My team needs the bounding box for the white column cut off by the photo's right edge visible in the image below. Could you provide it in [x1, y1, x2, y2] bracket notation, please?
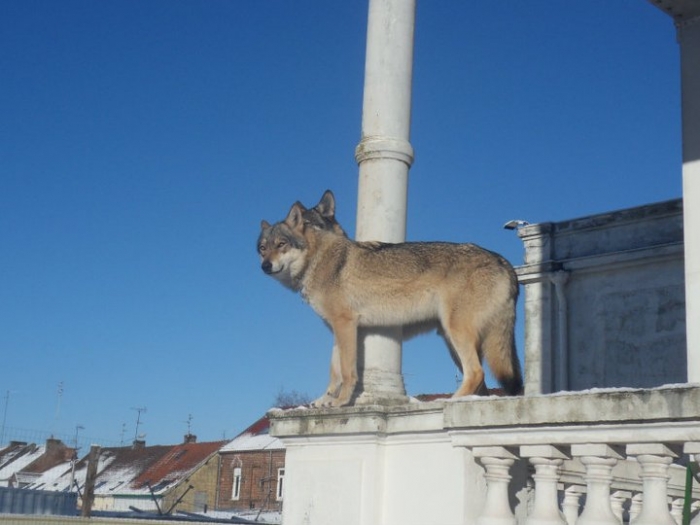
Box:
[677, 12, 700, 383]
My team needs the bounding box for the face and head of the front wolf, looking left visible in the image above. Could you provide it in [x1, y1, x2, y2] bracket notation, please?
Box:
[258, 202, 308, 290]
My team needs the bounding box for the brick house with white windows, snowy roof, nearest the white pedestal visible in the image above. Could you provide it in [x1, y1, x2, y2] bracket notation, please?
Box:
[217, 415, 285, 510]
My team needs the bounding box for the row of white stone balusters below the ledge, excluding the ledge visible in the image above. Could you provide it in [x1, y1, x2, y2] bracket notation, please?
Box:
[464, 442, 700, 525]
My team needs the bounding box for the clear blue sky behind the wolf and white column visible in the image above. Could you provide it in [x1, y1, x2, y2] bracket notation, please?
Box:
[0, 0, 681, 445]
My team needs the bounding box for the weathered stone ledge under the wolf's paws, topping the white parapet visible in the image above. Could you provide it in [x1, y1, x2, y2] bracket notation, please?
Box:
[268, 385, 700, 441]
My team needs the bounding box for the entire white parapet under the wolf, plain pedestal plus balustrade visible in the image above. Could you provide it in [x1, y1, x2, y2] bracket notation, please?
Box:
[270, 385, 700, 525]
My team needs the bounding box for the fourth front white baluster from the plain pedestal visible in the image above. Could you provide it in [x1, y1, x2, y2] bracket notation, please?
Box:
[627, 443, 678, 525]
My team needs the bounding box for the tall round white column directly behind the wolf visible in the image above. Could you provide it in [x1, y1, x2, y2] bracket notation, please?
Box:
[355, 0, 415, 403]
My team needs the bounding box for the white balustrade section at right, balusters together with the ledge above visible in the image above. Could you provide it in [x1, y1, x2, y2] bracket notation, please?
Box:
[448, 384, 700, 525]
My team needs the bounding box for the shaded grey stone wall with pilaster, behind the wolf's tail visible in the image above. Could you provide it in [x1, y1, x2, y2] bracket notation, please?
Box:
[518, 199, 687, 394]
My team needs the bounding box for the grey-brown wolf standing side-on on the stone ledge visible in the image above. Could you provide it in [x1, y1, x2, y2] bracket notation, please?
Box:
[257, 190, 523, 407]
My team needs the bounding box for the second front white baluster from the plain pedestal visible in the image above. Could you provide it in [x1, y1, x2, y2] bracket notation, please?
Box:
[520, 445, 568, 525]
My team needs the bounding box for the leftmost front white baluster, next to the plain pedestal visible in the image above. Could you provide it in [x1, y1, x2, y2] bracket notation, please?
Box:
[472, 447, 518, 525]
